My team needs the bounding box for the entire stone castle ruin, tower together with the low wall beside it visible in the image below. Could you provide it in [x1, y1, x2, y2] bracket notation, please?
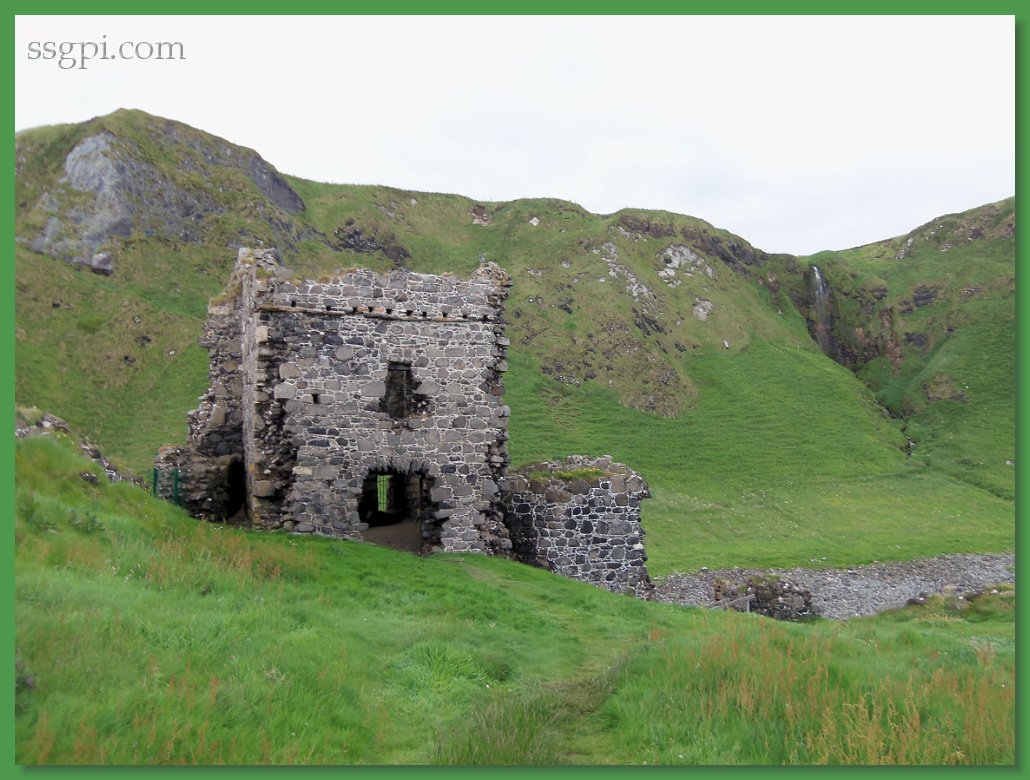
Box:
[156, 248, 651, 596]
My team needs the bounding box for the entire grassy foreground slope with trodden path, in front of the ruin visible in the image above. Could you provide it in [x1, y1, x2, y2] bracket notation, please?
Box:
[15, 437, 1016, 765]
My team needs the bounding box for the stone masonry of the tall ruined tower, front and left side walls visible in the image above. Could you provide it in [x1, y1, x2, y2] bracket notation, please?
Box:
[166, 249, 510, 551]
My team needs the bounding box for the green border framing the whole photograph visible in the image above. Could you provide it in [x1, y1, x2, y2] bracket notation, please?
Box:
[6, 0, 1030, 780]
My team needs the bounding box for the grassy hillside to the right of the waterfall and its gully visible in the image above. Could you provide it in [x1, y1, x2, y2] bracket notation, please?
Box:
[778, 198, 1016, 499]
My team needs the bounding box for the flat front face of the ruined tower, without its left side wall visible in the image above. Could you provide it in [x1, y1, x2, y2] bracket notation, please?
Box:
[244, 258, 509, 550]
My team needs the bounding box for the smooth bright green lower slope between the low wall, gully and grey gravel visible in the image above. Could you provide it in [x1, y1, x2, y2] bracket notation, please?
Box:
[508, 344, 1016, 574]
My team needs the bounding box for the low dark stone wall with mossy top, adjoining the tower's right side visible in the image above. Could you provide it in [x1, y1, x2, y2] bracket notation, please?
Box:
[504, 455, 654, 599]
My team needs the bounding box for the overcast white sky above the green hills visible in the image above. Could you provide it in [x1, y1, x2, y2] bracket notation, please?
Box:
[14, 15, 1016, 253]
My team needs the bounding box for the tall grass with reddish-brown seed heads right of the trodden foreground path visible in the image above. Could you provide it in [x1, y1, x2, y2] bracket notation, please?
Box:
[599, 618, 1016, 765]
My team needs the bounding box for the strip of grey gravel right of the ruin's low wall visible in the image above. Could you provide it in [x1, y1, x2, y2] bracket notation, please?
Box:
[655, 553, 1016, 619]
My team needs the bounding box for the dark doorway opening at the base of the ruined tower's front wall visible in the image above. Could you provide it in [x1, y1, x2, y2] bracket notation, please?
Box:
[357, 471, 440, 552]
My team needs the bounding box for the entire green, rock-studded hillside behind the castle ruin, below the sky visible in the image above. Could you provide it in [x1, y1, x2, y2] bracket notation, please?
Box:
[15, 111, 1015, 573]
